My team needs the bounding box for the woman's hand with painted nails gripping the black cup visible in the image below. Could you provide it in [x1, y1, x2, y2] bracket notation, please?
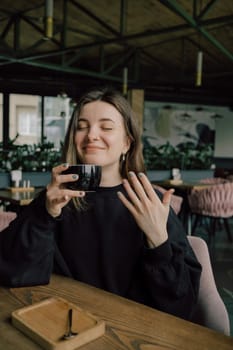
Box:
[45, 164, 85, 217]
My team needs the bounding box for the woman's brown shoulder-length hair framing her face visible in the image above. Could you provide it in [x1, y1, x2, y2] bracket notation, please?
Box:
[62, 87, 145, 178]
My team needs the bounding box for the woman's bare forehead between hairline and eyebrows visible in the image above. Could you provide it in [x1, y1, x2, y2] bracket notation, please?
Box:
[78, 101, 123, 124]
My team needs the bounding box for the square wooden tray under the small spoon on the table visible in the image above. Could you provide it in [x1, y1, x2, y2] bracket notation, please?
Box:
[12, 297, 105, 350]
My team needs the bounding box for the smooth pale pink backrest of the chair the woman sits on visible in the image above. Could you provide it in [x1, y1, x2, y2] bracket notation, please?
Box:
[187, 236, 230, 335]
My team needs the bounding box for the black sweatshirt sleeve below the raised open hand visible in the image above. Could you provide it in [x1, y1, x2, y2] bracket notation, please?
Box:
[141, 209, 201, 319]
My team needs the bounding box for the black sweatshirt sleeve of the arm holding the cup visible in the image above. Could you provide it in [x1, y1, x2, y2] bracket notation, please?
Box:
[0, 192, 57, 287]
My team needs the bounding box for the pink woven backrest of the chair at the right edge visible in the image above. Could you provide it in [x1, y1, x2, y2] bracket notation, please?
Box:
[188, 182, 233, 218]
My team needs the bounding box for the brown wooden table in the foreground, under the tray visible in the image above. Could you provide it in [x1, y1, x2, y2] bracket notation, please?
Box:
[0, 275, 233, 350]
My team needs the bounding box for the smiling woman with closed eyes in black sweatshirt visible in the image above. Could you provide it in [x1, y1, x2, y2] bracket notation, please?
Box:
[0, 88, 201, 319]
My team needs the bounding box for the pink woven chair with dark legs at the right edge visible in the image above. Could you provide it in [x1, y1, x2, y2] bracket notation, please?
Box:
[188, 182, 233, 242]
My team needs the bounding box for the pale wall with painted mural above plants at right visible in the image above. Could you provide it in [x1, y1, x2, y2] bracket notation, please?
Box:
[143, 101, 233, 158]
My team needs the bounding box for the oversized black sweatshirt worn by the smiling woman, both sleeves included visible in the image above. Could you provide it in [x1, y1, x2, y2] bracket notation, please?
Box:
[0, 185, 201, 319]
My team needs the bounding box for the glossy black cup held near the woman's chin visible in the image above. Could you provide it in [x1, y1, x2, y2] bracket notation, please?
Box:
[62, 164, 101, 192]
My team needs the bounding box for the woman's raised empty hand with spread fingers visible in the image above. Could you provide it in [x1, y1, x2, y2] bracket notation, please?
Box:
[118, 172, 174, 247]
